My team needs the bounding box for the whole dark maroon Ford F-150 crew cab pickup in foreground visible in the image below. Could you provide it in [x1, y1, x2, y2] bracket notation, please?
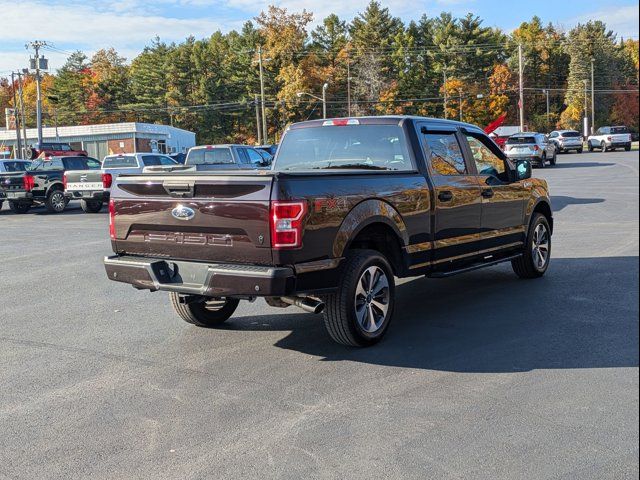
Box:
[105, 116, 553, 346]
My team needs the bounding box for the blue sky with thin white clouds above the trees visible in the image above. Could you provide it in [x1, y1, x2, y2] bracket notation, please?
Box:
[0, 0, 638, 76]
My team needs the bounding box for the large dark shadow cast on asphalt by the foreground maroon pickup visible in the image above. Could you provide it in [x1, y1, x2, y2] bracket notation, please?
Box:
[228, 256, 638, 373]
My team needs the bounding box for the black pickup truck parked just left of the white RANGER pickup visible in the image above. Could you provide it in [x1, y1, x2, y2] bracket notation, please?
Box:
[0, 156, 100, 213]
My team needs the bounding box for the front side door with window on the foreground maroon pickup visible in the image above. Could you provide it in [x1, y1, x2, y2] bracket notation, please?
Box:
[462, 130, 526, 251]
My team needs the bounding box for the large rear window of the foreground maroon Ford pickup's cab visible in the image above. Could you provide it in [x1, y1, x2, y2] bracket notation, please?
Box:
[275, 125, 413, 170]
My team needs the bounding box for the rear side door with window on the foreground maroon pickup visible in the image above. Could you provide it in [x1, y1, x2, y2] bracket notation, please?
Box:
[418, 124, 482, 268]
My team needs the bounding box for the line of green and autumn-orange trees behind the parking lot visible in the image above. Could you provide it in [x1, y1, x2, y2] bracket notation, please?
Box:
[0, 1, 638, 143]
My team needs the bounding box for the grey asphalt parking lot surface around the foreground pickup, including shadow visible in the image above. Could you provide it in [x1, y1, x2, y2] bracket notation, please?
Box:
[0, 152, 639, 479]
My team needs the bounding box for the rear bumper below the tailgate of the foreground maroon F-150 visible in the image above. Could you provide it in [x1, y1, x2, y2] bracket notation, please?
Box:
[104, 255, 296, 297]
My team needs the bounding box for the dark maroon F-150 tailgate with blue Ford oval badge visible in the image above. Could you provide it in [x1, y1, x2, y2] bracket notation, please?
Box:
[111, 173, 272, 265]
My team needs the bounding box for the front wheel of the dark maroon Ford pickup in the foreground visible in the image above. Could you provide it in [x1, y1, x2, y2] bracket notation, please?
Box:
[511, 213, 551, 278]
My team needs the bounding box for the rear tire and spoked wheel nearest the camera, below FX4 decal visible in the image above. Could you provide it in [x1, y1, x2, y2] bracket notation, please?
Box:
[324, 250, 395, 347]
